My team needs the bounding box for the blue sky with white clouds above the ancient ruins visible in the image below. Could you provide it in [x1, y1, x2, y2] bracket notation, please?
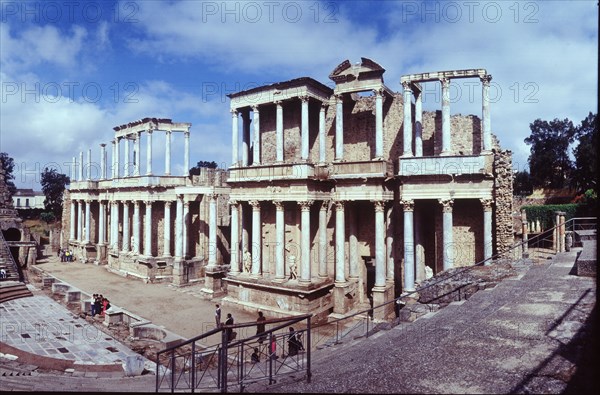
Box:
[0, 0, 598, 189]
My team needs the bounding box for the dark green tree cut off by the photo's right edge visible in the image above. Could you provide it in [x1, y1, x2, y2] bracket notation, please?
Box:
[572, 112, 598, 191]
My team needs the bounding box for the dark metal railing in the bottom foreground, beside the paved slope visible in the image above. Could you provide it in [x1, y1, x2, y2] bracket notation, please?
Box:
[156, 314, 312, 392]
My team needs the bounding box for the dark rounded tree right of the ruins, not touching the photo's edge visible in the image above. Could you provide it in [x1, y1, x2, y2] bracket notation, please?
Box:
[525, 119, 577, 188]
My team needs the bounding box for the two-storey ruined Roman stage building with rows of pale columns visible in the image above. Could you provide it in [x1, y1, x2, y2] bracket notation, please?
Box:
[63, 58, 513, 318]
